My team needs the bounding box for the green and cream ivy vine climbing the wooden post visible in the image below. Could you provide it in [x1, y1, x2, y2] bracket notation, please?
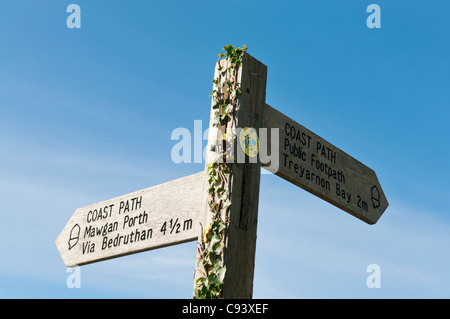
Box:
[193, 45, 247, 299]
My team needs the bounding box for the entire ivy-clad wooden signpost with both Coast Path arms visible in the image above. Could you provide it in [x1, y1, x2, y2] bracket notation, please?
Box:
[55, 46, 389, 299]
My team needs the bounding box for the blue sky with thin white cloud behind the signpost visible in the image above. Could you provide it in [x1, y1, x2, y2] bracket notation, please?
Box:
[0, 0, 450, 298]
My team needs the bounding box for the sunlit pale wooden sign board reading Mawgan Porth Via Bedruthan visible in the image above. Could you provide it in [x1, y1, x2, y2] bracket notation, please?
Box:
[55, 172, 204, 267]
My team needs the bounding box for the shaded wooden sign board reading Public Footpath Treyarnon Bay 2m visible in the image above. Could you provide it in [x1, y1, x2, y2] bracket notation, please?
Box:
[263, 104, 389, 224]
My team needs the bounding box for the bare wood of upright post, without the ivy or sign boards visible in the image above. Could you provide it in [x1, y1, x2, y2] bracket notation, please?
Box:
[194, 53, 267, 299]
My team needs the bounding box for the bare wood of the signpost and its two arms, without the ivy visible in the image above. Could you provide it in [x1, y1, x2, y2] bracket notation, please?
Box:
[55, 48, 389, 298]
